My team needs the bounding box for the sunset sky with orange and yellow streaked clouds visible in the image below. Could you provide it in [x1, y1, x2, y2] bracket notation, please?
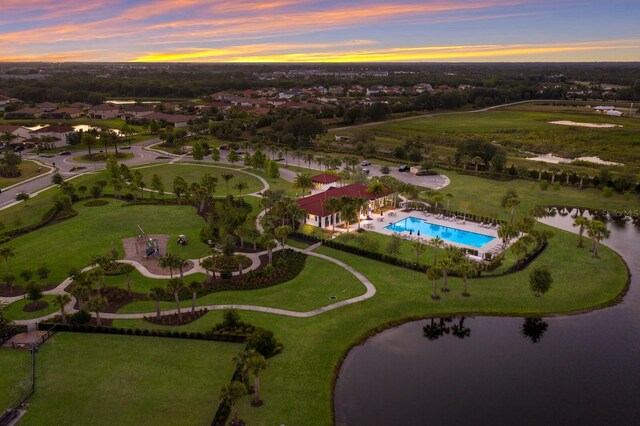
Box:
[0, 0, 640, 62]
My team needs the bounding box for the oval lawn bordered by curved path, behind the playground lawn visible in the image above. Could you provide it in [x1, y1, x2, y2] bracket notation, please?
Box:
[138, 163, 264, 195]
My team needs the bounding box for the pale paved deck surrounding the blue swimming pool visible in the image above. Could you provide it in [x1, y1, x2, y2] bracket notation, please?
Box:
[356, 209, 503, 256]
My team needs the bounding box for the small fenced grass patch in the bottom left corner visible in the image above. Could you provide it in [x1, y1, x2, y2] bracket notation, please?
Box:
[0, 348, 31, 412]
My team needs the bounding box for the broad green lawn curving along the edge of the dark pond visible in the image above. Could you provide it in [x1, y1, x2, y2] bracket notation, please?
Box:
[115, 226, 627, 425]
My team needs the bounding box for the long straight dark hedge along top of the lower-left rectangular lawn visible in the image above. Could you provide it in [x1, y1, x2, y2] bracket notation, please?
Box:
[38, 322, 247, 342]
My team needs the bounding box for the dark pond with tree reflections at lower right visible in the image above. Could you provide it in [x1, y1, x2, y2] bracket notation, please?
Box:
[335, 210, 640, 425]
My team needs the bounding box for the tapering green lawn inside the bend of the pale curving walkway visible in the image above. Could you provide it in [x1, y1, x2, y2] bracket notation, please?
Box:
[118, 256, 365, 313]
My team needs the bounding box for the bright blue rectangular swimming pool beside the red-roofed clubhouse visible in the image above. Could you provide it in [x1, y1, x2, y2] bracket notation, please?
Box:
[385, 216, 495, 248]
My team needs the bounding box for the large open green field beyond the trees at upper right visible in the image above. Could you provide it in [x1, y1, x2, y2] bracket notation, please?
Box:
[335, 106, 640, 166]
